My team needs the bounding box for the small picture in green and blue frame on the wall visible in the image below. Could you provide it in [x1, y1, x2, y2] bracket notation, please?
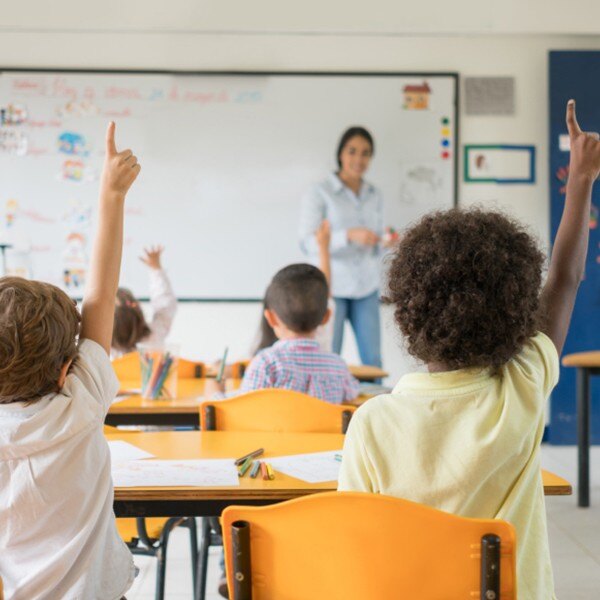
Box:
[464, 144, 535, 184]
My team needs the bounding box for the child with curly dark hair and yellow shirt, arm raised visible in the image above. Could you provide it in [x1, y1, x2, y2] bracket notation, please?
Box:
[339, 101, 600, 600]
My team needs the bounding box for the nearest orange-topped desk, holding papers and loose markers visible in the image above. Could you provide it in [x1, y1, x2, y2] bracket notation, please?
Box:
[106, 431, 571, 517]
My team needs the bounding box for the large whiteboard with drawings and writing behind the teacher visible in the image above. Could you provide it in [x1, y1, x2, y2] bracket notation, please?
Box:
[0, 71, 458, 299]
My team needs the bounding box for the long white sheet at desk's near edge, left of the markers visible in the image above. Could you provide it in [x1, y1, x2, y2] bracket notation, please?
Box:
[112, 458, 240, 487]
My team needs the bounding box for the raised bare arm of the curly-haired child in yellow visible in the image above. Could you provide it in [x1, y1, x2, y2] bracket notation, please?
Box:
[541, 100, 600, 355]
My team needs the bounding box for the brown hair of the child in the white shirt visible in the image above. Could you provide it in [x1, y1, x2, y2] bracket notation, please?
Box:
[0, 277, 81, 403]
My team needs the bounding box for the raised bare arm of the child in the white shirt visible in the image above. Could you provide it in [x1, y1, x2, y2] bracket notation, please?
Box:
[81, 123, 141, 354]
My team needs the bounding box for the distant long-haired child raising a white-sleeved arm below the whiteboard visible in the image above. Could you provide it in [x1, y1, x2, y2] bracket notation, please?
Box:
[111, 246, 177, 358]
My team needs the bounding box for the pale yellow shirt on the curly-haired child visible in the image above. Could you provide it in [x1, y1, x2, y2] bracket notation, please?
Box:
[338, 333, 559, 600]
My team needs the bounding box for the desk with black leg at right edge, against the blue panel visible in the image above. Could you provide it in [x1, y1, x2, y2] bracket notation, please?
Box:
[562, 352, 600, 508]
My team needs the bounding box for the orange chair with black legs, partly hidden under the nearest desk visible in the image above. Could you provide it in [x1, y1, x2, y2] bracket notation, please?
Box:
[103, 425, 198, 600]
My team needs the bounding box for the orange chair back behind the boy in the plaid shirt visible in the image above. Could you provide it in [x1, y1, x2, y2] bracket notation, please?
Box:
[200, 389, 355, 433]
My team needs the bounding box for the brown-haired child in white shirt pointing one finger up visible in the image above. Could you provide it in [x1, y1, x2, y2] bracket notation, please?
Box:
[0, 123, 140, 600]
